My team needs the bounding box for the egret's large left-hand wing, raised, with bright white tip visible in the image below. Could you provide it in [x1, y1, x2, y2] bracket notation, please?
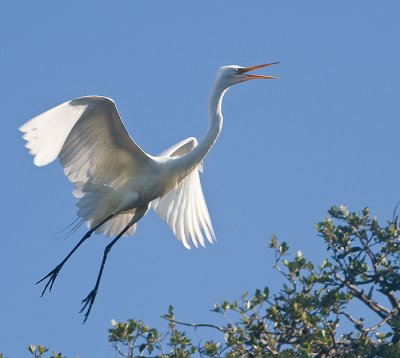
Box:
[20, 96, 153, 235]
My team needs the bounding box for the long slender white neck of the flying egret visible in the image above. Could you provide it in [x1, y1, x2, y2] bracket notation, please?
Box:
[174, 82, 228, 175]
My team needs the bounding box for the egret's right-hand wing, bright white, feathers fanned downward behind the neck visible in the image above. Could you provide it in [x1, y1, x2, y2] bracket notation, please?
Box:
[152, 138, 216, 249]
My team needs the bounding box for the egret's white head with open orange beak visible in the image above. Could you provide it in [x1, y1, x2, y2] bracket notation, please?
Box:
[217, 62, 279, 88]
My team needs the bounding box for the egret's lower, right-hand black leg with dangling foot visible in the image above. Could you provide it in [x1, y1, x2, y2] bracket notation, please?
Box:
[79, 207, 148, 323]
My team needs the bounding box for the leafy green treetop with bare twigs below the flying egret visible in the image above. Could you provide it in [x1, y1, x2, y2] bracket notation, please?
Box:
[10, 206, 400, 358]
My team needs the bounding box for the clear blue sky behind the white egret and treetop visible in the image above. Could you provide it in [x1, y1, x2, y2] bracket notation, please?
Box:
[0, 0, 400, 357]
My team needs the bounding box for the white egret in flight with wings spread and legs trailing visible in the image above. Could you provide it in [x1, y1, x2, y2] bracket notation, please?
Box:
[19, 62, 278, 323]
